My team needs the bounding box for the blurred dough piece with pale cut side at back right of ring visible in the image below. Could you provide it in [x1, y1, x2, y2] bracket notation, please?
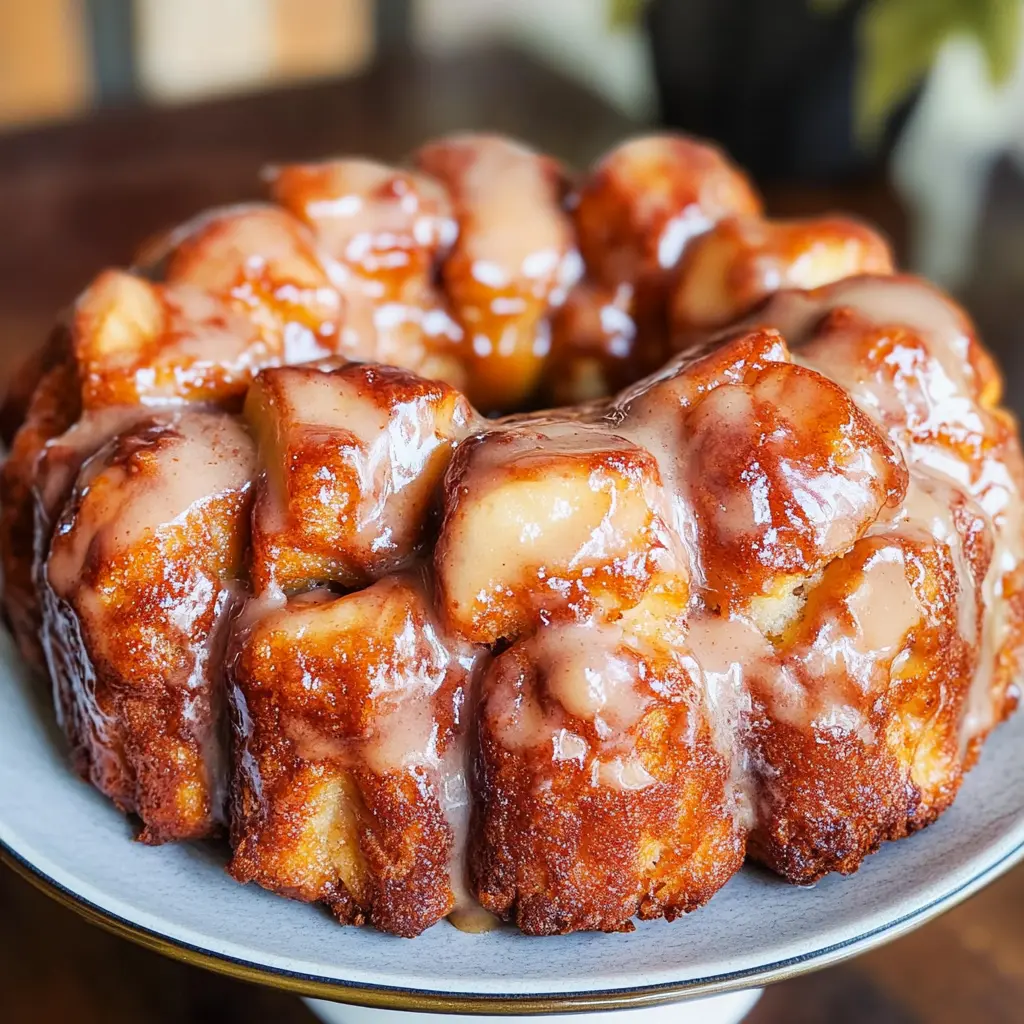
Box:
[670, 217, 893, 341]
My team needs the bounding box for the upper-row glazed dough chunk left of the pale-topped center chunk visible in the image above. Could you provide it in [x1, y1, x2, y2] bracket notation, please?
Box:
[246, 364, 474, 592]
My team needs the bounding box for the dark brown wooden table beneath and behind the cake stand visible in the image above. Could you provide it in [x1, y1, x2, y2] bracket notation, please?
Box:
[0, 44, 1024, 1024]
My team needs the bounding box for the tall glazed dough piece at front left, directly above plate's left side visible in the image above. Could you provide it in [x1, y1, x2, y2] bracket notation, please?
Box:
[43, 413, 255, 843]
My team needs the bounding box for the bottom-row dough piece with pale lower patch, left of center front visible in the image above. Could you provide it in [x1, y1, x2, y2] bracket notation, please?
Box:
[230, 577, 478, 937]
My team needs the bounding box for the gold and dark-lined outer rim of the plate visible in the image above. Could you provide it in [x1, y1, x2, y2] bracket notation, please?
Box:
[6, 841, 1024, 1015]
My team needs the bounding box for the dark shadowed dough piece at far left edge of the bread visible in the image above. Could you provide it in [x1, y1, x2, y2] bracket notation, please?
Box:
[0, 361, 78, 669]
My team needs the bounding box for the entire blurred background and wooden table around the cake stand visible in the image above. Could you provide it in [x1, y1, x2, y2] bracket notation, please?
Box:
[0, 0, 1024, 1024]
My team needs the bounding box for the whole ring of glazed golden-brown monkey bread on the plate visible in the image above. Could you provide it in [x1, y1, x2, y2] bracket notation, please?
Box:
[0, 135, 1024, 936]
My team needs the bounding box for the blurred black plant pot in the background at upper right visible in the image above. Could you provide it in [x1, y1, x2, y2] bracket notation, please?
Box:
[645, 0, 916, 182]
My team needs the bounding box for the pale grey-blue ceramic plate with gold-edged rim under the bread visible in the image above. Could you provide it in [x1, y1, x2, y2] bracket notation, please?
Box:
[0, 637, 1024, 1013]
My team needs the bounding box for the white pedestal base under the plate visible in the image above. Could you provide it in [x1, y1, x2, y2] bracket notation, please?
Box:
[303, 988, 762, 1024]
